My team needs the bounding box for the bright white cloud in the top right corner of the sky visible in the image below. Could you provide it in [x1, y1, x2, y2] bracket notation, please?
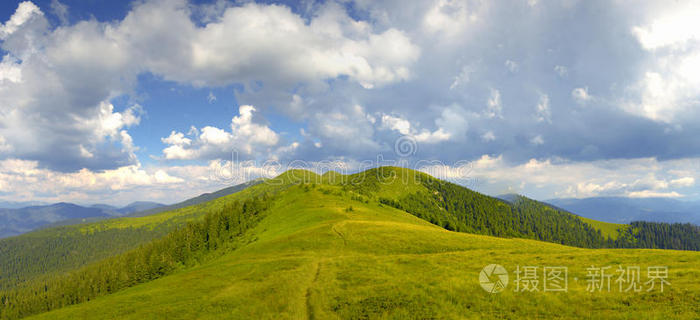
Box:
[623, 1, 700, 123]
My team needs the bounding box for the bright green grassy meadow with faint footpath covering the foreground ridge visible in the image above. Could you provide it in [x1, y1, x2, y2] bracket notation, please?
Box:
[30, 185, 700, 319]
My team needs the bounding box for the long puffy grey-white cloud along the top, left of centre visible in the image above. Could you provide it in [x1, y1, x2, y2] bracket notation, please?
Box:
[143, 2, 420, 88]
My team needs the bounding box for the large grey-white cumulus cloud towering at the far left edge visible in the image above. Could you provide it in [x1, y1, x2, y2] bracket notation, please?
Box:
[0, 2, 141, 171]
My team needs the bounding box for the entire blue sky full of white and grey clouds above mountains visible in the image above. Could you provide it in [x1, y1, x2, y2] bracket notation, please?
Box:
[0, 0, 700, 204]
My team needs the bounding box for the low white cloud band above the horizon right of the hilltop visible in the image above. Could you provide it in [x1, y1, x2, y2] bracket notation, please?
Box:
[438, 155, 700, 199]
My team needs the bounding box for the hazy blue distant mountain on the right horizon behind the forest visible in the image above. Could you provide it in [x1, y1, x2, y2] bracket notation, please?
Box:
[547, 197, 700, 225]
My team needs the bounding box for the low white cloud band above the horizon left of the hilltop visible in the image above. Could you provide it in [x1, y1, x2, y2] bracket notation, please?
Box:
[0, 159, 281, 205]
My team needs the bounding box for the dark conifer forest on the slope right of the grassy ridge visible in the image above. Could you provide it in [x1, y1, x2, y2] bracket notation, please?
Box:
[379, 176, 700, 250]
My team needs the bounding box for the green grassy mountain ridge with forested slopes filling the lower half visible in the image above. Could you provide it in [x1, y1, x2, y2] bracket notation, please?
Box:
[0, 168, 700, 319]
